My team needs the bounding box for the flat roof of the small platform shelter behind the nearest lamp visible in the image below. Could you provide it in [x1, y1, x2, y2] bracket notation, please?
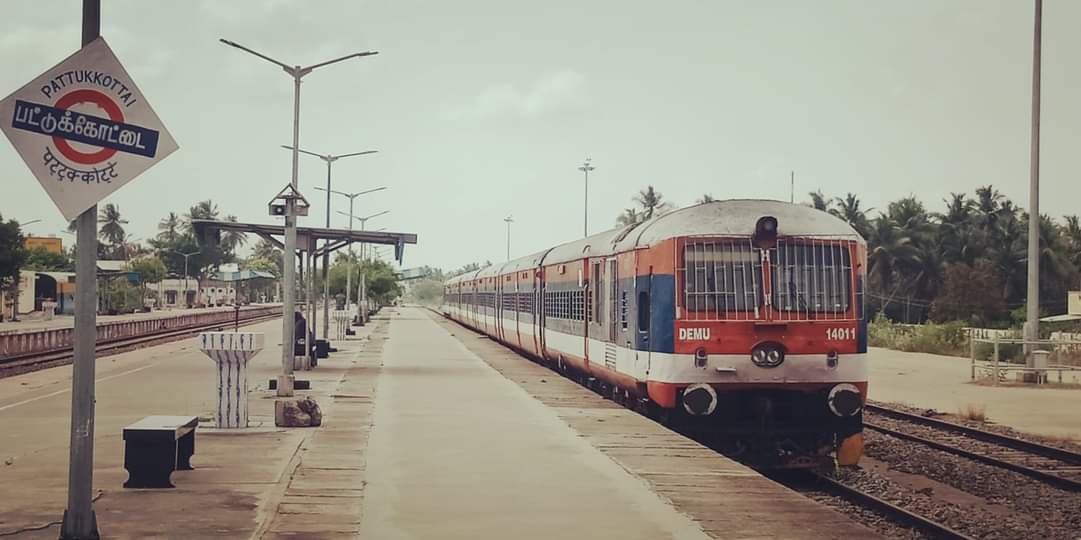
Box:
[191, 219, 416, 264]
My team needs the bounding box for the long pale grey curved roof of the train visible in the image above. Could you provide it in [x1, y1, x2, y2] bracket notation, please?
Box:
[448, 199, 864, 284]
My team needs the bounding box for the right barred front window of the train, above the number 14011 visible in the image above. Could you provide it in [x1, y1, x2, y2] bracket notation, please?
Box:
[770, 240, 852, 314]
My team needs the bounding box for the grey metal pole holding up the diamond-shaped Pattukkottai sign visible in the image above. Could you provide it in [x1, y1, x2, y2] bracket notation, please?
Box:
[59, 0, 102, 539]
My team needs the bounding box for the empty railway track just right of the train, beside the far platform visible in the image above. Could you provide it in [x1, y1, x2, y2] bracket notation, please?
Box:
[864, 404, 1081, 491]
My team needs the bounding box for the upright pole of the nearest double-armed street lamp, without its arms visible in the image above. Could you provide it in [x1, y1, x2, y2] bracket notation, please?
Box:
[277, 70, 301, 397]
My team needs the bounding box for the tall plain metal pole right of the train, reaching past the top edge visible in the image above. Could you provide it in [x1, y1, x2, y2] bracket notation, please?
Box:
[1024, 0, 1043, 367]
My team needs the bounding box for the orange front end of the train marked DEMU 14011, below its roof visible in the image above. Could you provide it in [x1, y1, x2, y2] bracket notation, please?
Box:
[639, 232, 867, 467]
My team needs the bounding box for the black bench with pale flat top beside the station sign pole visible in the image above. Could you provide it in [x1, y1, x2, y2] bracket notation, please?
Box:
[124, 416, 199, 488]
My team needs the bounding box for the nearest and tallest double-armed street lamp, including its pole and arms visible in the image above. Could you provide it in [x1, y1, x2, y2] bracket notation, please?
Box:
[218, 39, 378, 397]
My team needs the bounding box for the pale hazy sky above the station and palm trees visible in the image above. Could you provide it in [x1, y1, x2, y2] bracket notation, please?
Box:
[0, 0, 1081, 269]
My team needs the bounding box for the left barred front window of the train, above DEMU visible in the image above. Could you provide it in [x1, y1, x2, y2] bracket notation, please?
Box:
[682, 241, 762, 319]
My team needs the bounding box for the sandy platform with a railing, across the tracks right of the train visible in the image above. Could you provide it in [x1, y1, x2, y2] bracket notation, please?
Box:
[868, 348, 1081, 443]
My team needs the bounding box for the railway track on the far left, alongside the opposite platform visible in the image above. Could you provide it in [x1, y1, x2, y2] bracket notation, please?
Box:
[0, 313, 281, 378]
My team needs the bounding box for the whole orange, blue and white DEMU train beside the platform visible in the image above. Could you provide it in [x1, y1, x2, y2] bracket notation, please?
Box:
[441, 199, 868, 469]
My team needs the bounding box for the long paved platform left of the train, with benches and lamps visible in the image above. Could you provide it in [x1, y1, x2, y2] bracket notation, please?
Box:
[0, 308, 876, 540]
